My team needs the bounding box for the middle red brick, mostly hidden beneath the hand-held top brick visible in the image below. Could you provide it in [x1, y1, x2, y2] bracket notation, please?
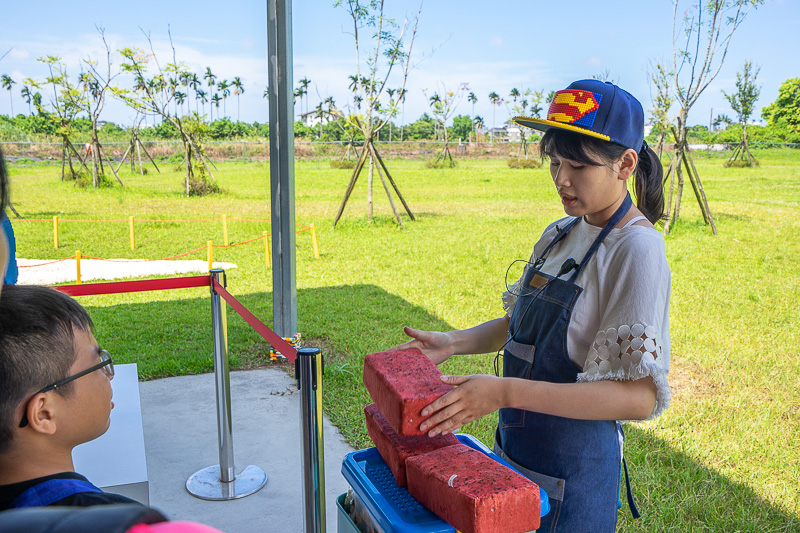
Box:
[364, 403, 459, 487]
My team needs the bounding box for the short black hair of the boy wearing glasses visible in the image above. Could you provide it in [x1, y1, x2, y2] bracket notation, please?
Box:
[0, 285, 94, 453]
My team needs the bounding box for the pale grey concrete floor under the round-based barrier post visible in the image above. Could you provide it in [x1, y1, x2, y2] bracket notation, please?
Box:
[139, 368, 353, 533]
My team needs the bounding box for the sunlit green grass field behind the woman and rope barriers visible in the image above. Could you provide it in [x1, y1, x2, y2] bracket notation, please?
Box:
[6, 149, 800, 532]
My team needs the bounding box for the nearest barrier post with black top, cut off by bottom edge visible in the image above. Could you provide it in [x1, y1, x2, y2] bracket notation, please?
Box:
[295, 348, 325, 533]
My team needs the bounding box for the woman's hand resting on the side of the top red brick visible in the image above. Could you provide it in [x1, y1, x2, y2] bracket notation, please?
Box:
[420, 374, 506, 437]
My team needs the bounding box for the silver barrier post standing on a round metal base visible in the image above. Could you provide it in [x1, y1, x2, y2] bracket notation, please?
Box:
[186, 268, 267, 500]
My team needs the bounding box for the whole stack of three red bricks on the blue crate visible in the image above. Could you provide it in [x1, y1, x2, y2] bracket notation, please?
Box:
[364, 349, 540, 533]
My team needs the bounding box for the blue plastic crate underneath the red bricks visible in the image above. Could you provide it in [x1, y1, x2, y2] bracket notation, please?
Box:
[342, 433, 550, 533]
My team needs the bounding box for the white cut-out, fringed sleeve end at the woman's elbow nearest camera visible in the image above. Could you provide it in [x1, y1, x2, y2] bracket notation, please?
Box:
[578, 324, 670, 422]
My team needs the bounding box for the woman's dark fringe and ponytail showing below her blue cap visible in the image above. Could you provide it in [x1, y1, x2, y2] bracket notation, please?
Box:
[539, 128, 664, 224]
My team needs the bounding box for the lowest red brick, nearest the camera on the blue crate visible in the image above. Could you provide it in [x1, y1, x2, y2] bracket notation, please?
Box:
[406, 444, 540, 533]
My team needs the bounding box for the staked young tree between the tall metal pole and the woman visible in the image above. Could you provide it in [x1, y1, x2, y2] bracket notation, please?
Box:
[333, 0, 421, 228]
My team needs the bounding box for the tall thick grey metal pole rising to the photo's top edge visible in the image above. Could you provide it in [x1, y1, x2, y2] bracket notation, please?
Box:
[267, 0, 297, 337]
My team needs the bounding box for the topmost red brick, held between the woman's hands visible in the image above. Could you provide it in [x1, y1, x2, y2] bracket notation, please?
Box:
[364, 348, 455, 437]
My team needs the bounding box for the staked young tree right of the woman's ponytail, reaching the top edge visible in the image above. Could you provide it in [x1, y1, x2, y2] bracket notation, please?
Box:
[664, 0, 763, 235]
